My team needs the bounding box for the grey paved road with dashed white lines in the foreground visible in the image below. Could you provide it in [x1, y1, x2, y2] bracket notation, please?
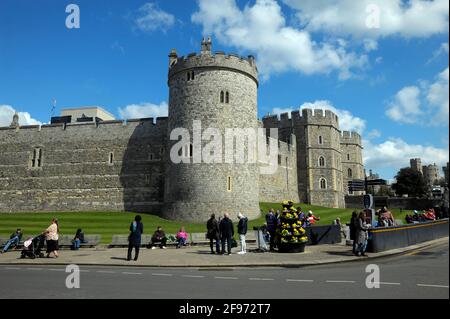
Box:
[0, 244, 449, 299]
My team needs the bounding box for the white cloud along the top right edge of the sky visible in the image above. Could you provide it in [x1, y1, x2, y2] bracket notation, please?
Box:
[283, 0, 449, 38]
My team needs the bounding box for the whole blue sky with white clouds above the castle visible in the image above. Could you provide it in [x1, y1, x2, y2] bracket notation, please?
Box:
[0, 0, 449, 179]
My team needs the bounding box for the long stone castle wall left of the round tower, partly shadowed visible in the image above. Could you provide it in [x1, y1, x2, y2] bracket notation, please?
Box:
[0, 119, 167, 213]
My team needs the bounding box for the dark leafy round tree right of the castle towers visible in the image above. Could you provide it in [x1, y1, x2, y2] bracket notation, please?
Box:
[392, 167, 428, 197]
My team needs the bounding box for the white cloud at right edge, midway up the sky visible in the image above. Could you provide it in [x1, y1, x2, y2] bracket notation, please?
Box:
[386, 67, 449, 126]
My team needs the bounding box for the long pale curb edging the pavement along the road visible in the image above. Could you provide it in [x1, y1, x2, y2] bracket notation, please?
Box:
[0, 237, 449, 269]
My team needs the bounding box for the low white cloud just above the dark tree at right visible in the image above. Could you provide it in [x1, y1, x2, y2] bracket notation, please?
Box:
[363, 137, 449, 170]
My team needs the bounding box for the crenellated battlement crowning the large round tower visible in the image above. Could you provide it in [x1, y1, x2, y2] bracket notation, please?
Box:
[169, 40, 258, 85]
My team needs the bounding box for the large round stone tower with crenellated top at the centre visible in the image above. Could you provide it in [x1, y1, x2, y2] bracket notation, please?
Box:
[162, 39, 260, 222]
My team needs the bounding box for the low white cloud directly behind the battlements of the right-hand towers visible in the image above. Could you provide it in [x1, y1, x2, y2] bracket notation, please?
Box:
[272, 101, 366, 134]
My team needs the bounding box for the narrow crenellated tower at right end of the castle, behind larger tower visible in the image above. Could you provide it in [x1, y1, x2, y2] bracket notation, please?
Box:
[341, 131, 365, 195]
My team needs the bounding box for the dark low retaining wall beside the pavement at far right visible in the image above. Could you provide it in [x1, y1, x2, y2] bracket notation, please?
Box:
[367, 219, 449, 253]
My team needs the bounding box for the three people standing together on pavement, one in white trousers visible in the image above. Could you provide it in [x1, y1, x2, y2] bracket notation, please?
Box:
[206, 213, 248, 255]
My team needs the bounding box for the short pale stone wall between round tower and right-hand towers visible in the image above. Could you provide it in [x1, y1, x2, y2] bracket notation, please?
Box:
[259, 136, 299, 203]
